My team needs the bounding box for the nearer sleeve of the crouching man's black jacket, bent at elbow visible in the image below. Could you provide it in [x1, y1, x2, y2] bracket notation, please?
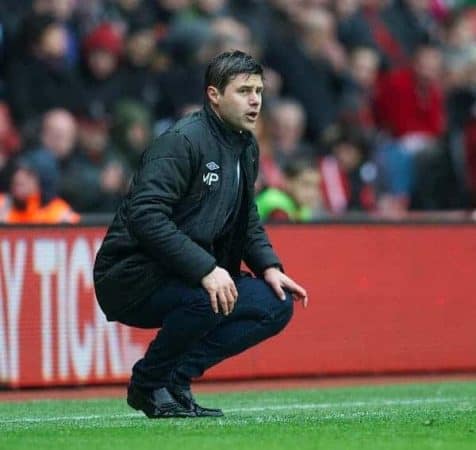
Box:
[127, 132, 216, 285]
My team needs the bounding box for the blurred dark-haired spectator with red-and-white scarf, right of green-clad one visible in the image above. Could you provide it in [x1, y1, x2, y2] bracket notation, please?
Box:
[319, 126, 377, 214]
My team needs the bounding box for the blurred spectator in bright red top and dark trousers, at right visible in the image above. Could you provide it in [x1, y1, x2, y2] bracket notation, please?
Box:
[376, 44, 452, 209]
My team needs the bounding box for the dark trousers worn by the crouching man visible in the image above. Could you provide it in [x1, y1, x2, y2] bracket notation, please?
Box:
[119, 276, 293, 389]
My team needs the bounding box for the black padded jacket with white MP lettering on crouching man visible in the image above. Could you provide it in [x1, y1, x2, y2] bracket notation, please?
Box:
[94, 105, 281, 320]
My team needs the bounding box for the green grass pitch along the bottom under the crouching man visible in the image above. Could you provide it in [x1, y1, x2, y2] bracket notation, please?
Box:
[0, 382, 476, 450]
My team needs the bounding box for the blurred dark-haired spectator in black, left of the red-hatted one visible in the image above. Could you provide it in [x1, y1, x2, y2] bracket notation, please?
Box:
[7, 15, 80, 126]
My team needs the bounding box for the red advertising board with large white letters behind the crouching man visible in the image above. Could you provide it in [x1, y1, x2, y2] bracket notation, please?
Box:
[0, 225, 476, 386]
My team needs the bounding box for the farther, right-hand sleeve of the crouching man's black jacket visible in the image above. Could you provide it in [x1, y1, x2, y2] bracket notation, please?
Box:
[244, 147, 283, 276]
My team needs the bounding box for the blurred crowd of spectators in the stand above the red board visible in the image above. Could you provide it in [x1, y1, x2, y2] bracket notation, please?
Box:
[0, 0, 476, 223]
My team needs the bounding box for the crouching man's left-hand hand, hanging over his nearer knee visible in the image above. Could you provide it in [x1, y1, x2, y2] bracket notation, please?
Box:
[202, 266, 238, 316]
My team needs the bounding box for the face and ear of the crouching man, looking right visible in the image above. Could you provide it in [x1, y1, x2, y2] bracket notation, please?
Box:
[209, 73, 263, 131]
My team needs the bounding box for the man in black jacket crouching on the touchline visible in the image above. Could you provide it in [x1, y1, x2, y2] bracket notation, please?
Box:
[94, 51, 307, 418]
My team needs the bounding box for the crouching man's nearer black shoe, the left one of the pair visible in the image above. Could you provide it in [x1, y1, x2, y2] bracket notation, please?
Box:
[127, 384, 197, 419]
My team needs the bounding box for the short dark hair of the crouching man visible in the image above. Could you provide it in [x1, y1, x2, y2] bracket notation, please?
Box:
[205, 50, 263, 93]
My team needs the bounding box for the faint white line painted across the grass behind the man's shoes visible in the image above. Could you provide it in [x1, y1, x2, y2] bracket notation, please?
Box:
[0, 397, 466, 426]
